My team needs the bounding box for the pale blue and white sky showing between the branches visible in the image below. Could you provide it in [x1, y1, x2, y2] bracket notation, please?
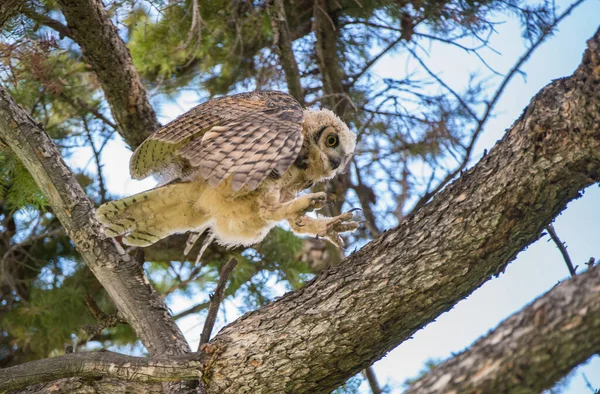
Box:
[71, 0, 600, 394]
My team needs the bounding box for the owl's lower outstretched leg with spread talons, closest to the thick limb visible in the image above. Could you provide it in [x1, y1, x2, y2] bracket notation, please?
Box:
[287, 212, 359, 247]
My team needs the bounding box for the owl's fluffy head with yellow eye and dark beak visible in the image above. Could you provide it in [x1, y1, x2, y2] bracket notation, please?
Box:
[296, 109, 356, 181]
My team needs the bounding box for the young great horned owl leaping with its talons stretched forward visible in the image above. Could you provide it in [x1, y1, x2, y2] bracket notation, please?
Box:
[97, 91, 358, 260]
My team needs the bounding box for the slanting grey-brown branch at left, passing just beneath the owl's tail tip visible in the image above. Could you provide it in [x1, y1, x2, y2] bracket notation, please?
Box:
[0, 87, 189, 355]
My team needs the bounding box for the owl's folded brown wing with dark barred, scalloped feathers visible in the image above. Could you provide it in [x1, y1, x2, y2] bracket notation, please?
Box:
[130, 91, 304, 190]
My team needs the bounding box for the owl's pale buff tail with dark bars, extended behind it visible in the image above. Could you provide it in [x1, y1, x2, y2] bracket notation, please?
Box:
[96, 184, 207, 246]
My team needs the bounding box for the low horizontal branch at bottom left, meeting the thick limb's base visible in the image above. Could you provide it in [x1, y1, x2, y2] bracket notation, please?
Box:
[0, 351, 210, 391]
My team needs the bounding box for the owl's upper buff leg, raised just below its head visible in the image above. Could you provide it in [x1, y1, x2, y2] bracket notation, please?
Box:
[259, 192, 330, 221]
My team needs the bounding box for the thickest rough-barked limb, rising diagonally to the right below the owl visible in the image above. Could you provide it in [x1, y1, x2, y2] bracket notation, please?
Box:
[4, 20, 600, 393]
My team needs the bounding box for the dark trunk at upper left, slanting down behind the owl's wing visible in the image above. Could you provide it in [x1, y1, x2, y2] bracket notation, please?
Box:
[58, 0, 160, 148]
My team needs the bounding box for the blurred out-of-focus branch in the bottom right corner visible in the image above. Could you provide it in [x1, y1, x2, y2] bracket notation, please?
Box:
[405, 266, 600, 394]
